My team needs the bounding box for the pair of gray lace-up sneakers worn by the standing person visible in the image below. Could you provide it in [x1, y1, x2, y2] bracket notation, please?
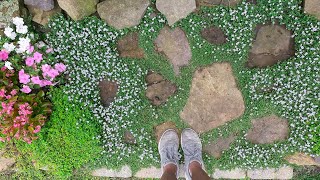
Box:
[158, 128, 203, 180]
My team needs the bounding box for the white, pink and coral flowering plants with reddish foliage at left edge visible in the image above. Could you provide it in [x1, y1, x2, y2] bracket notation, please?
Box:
[0, 17, 66, 143]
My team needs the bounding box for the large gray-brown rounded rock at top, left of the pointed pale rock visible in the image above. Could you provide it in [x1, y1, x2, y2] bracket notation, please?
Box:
[98, 0, 150, 29]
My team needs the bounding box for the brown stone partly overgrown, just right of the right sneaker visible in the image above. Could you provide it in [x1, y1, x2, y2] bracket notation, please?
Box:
[203, 135, 236, 158]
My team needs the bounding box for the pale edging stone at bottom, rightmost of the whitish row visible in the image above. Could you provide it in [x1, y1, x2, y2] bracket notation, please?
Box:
[247, 166, 293, 179]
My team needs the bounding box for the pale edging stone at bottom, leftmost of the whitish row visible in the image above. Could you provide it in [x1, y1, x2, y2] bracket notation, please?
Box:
[91, 166, 132, 178]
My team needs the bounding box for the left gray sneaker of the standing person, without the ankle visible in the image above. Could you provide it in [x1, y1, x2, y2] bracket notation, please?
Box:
[158, 129, 179, 178]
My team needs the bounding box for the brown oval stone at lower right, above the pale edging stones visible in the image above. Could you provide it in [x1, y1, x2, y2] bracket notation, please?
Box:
[247, 115, 289, 144]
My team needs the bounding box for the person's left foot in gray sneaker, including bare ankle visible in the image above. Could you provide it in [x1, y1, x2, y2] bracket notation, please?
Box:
[158, 129, 179, 180]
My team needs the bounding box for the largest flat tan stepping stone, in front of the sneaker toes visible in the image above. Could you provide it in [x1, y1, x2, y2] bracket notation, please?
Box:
[180, 62, 245, 133]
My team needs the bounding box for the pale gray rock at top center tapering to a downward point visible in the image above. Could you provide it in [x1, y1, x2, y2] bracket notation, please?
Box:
[156, 0, 197, 26]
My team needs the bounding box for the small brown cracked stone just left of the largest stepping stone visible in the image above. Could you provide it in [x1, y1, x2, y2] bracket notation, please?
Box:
[146, 73, 177, 106]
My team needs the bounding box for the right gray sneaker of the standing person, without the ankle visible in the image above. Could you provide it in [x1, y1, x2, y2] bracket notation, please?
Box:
[181, 128, 204, 180]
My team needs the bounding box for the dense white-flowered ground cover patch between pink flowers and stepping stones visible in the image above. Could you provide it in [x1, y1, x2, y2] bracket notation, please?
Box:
[47, 17, 155, 165]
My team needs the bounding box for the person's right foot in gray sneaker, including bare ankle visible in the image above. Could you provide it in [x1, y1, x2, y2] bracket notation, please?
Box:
[181, 128, 210, 180]
